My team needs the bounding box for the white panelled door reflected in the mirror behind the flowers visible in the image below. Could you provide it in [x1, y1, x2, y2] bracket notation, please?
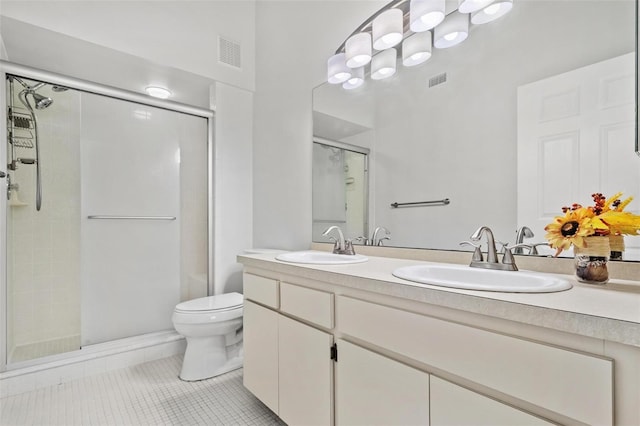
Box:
[514, 53, 640, 260]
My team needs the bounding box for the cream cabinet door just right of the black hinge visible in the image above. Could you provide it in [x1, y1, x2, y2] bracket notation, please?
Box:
[336, 340, 429, 426]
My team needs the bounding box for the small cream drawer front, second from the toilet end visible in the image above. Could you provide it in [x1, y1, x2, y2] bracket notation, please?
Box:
[280, 282, 334, 328]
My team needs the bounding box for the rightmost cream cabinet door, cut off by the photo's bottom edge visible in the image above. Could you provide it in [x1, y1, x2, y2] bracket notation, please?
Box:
[431, 376, 553, 426]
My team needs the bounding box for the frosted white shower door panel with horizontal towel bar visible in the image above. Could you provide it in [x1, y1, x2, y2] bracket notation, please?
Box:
[80, 94, 181, 345]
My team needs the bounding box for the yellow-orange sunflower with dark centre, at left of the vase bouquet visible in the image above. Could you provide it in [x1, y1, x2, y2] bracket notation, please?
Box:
[544, 207, 607, 256]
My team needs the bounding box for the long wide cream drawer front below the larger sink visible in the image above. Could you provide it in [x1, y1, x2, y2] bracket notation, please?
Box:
[336, 296, 613, 425]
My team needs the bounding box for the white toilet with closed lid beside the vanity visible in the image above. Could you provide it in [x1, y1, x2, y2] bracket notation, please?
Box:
[172, 293, 243, 382]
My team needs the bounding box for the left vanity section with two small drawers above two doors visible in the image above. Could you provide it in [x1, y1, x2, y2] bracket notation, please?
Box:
[243, 274, 334, 426]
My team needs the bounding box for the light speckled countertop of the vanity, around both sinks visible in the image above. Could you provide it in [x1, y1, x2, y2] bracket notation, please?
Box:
[238, 254, 640, 347]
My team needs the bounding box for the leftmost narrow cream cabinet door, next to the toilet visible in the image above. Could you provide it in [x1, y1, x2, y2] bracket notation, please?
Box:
[243, 300, 278, 414]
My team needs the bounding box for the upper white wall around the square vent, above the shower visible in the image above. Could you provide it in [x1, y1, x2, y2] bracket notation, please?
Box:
[0, 0, 255, 90]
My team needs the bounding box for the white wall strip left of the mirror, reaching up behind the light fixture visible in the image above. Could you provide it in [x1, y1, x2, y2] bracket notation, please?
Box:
[253, 0, 387, 250]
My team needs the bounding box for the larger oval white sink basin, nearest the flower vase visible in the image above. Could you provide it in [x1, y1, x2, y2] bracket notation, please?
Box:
[393, 265, 572, 293]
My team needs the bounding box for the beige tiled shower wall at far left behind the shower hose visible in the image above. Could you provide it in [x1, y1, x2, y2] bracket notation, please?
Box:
[7, 85, 80, 358]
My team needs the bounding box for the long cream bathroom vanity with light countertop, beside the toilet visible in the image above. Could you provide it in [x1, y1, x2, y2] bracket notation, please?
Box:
[238, 254, 640, 426]
